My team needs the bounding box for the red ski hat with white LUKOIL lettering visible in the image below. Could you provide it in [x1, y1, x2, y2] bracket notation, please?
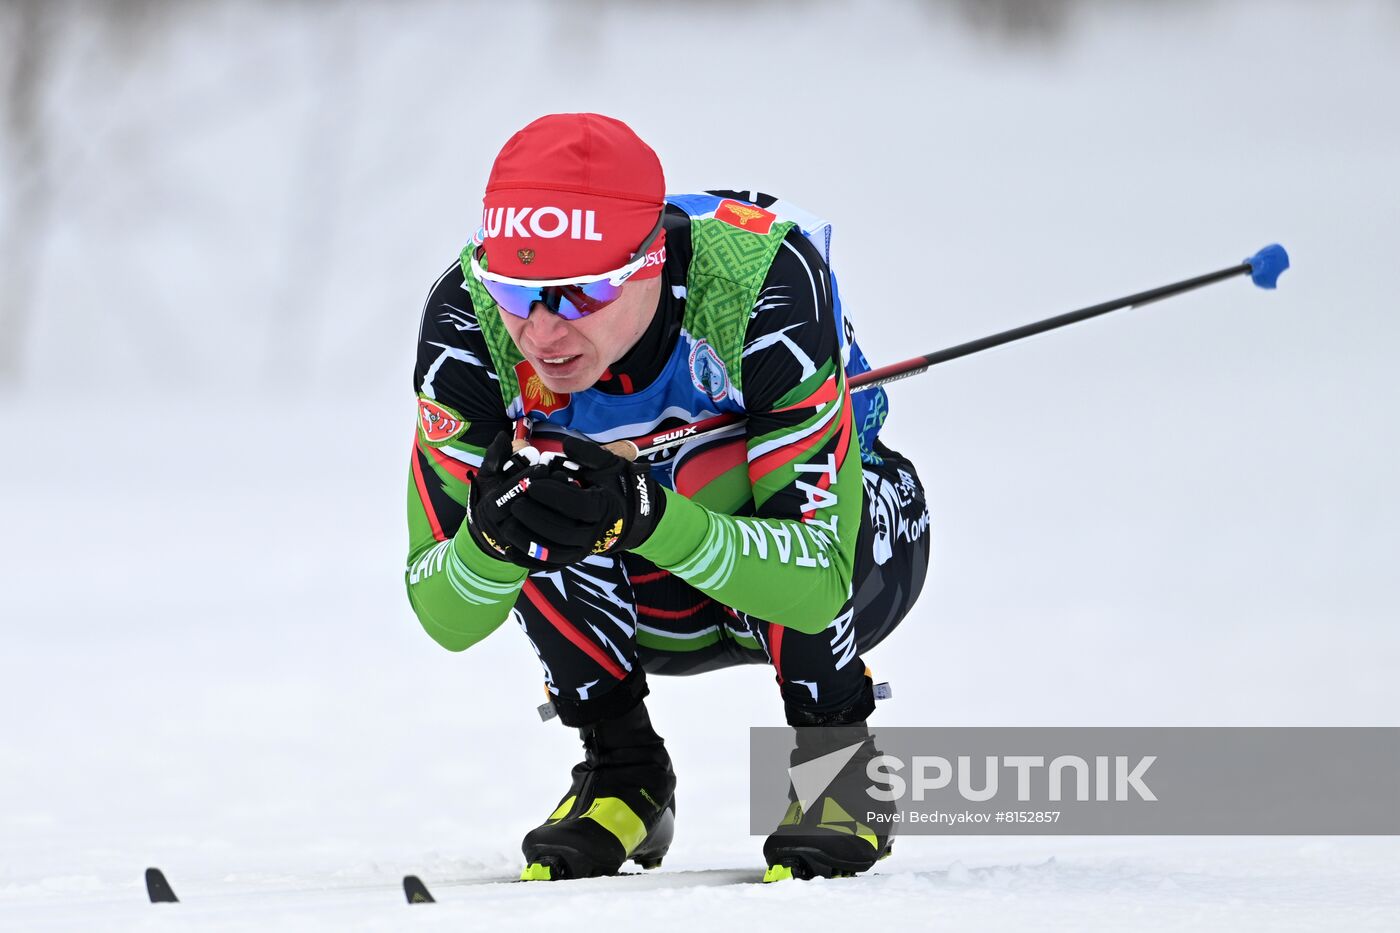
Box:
[482, 113, 666, 279]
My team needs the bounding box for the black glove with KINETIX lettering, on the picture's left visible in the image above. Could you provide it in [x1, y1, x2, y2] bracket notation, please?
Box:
[466, 431, 562, 570]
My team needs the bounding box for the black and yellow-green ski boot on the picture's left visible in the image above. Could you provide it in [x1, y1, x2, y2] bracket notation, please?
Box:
[521, 702, 676, 881]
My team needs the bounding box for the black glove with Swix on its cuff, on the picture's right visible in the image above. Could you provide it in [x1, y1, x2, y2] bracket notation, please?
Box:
[505, 437, 666, 566]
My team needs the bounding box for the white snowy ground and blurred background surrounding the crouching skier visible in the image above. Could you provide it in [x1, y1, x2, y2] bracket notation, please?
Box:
[0, 0, 1400, 930]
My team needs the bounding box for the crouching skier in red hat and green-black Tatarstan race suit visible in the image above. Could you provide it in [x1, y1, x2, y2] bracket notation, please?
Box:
[406, 113, 928, 880]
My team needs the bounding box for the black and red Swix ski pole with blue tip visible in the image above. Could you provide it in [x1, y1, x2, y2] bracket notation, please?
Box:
[605, 242, 1288, 459]
